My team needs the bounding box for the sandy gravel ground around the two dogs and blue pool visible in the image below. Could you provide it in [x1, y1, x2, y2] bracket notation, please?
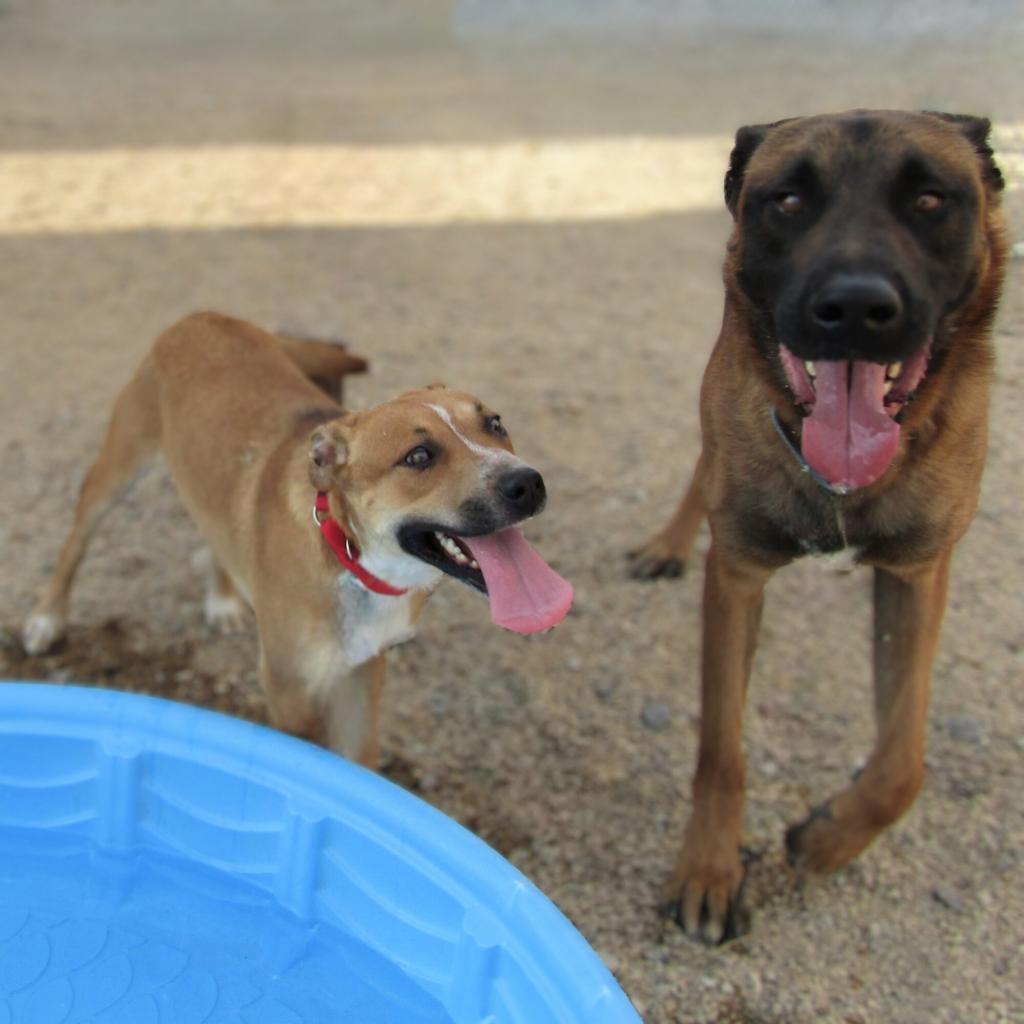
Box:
[0, 0, 1024, 1024]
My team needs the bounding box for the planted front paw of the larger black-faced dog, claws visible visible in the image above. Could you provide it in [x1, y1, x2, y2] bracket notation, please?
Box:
[662, 849, 751, 946]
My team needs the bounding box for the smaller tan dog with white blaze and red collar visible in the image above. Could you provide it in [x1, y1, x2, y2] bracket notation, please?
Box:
[23, 313, 572, 767]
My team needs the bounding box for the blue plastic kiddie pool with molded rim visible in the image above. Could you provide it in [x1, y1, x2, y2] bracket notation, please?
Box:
[0, 683, 640, 1024]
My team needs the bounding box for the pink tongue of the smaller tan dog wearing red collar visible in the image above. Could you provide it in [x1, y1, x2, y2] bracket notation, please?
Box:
[460, 527, 572, 633]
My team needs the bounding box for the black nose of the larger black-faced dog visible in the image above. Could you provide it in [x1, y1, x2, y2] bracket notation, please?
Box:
[806, 272, 903, 354]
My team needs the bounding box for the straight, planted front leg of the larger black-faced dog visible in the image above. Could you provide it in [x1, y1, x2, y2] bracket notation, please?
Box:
[667, 543, 770, 944]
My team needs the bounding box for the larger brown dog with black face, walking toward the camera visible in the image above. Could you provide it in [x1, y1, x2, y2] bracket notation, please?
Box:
[633, 111, 1006, 943]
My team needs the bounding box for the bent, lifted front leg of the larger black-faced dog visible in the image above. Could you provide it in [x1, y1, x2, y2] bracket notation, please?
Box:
[786, 549, 952, 872]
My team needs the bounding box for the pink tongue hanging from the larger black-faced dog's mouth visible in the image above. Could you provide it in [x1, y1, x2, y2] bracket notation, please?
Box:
[801, 360, 899, 490]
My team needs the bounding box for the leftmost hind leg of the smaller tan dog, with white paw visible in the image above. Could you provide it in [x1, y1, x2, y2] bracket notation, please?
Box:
[22, 359, 160, 654]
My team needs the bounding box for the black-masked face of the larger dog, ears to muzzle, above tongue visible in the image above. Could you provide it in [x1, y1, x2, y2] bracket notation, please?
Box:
[725, 112, 1001, 370]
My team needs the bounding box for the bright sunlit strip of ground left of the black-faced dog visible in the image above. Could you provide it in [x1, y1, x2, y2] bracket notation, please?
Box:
[0, 135, 731, 234]
